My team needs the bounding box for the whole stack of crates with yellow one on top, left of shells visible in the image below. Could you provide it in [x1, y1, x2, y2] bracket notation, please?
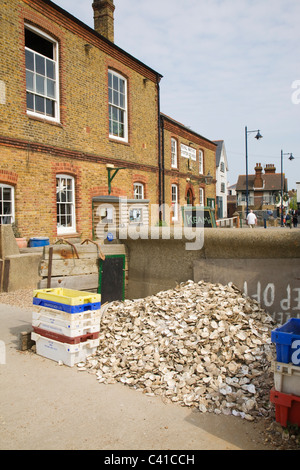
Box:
[31, 288, 101, 367]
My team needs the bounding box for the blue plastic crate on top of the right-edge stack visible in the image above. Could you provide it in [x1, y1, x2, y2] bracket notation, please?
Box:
[271, 318, 300, 366]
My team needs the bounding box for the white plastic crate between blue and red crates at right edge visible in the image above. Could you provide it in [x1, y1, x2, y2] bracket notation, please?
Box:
[272, 361, 300, 396]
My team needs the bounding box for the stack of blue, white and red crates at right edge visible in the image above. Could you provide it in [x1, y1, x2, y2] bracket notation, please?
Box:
[270, 318, 300, 427]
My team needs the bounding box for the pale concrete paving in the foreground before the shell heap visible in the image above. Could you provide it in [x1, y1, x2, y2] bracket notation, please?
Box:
[0, 304, 282, 451]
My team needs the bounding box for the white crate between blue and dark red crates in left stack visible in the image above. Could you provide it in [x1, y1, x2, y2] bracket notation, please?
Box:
[32, 311, 100, 338]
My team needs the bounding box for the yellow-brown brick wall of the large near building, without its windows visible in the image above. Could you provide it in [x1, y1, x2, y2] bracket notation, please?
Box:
[0, 0, 159, 240]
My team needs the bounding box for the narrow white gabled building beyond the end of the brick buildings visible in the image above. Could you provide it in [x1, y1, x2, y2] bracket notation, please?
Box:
[214, 140, 228, 219]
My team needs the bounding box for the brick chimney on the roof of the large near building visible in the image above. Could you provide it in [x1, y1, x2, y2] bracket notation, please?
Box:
[92, 0, 115, 42]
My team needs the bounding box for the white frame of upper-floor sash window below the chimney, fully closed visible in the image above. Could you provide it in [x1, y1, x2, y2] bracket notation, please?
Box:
[108, 70, 128, 142]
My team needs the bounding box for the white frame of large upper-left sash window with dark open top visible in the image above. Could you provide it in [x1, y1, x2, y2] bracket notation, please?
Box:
[24, 24, 60, 122]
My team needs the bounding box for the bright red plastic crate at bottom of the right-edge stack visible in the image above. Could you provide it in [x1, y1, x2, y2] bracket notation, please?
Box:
[270, 388, 300, 427]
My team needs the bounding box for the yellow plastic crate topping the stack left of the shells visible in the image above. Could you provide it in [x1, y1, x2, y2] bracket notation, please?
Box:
[33, 287, 101, 305]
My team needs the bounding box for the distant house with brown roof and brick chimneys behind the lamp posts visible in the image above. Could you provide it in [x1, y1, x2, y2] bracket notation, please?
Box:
[236, 163, 288, 210]
